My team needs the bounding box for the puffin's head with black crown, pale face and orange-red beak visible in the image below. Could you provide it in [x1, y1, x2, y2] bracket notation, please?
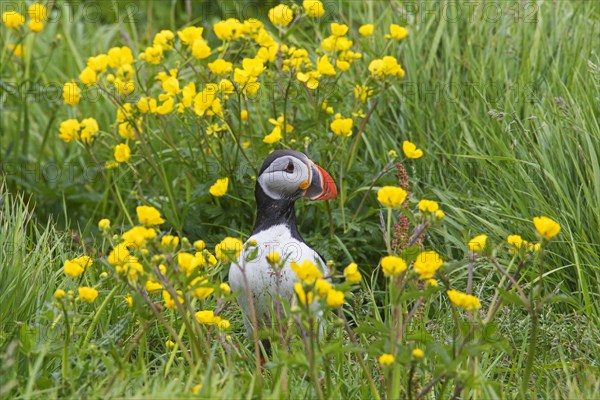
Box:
[256, 150, 337, 202]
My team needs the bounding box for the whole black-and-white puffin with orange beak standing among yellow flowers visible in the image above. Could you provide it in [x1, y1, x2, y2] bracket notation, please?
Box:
[229, 150, 337, 346]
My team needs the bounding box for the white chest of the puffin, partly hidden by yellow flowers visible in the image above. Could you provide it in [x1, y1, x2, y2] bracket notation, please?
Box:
[229, 224, 328, 324]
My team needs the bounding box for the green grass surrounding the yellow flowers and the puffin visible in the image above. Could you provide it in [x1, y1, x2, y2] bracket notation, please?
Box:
[0, 1, 600, 399]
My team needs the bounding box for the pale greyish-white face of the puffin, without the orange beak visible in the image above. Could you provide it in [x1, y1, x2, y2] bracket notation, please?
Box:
[258, 153, 312, 200]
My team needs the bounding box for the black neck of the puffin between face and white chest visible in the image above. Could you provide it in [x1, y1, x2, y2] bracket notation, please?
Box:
[252, 183, 304, 242]
